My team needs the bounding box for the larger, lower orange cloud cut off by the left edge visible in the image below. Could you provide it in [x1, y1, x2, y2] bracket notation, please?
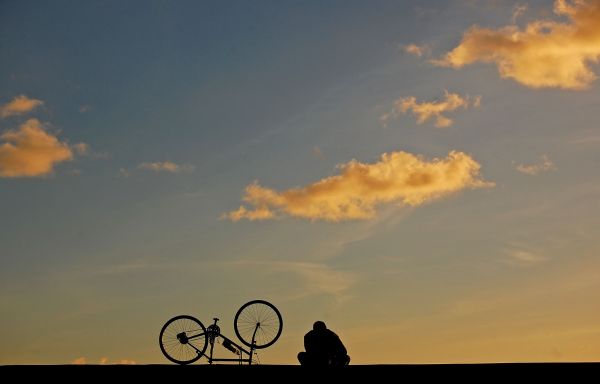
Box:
[0, 119, 78, 177]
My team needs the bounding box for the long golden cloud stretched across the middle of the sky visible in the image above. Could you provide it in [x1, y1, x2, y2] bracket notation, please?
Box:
[223, 151, 494, 222]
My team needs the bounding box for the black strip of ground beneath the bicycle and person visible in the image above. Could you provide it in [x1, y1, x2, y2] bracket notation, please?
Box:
[0, 363, 600, 384]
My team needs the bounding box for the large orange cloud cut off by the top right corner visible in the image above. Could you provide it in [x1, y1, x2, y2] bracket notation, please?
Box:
[432, 0, 600, 90]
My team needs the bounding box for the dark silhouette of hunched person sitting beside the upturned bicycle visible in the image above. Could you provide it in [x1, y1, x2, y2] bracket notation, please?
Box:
[298, 320, 350, 366]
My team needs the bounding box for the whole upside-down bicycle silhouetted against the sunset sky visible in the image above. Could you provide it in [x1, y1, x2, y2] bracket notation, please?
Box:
[158, 300, 283, 364]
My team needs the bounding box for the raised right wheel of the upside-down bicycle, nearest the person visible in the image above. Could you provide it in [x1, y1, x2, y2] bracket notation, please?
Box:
[233, 300, 283, 349]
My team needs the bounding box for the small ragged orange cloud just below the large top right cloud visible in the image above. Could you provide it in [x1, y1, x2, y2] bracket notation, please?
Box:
[379, 90, 481, 128]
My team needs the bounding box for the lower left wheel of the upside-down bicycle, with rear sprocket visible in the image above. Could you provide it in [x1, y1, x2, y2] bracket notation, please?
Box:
[158, 315, 206, 364]
